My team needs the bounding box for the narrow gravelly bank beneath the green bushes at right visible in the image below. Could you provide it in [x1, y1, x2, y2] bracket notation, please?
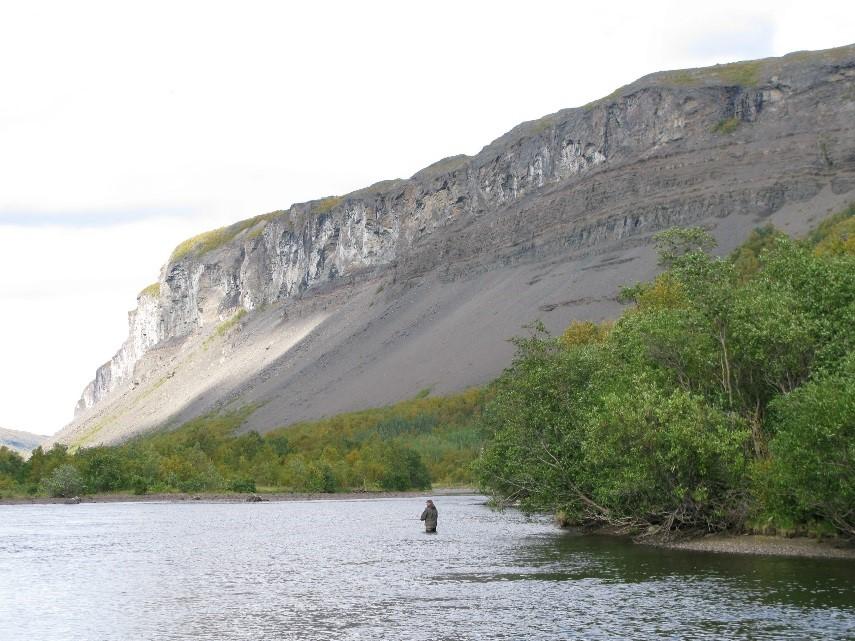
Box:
[651, 534, 855, 560]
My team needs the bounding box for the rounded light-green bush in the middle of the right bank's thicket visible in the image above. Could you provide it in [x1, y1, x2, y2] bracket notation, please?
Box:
[579, 377, 748, 531]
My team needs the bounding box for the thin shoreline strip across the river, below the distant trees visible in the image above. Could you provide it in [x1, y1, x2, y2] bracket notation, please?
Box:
[0, 487, 478, 505]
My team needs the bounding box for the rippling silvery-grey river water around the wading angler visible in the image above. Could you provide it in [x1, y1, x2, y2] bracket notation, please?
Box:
[0, 496, 855, 641]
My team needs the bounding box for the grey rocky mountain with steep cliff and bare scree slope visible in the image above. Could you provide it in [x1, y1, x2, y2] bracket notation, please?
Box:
[56, 46, 855, 445]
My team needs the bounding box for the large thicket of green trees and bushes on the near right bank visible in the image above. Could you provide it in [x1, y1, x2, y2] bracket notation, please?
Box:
[477, 208, 855, 537]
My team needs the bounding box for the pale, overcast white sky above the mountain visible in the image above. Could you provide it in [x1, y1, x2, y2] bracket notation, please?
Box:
[0, 0, 855, 434]
